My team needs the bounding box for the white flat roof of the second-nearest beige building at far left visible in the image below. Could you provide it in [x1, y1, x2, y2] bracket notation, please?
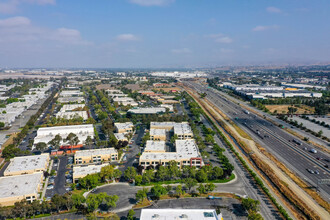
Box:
[5, 154, 49, 173]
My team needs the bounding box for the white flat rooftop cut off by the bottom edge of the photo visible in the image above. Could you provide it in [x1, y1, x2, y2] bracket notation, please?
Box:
[140, 209, 222, 220]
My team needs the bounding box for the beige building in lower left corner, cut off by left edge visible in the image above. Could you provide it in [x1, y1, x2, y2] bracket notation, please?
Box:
[0, 172, 43, 206]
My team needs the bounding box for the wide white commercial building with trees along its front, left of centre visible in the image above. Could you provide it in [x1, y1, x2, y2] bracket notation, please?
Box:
[34, 124, 94, 145]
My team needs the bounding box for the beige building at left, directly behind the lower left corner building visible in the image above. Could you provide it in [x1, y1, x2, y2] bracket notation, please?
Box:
[4, 154, 49, 176]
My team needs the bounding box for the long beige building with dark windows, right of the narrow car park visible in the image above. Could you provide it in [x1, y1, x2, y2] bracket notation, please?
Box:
[74, 148, 118, 164]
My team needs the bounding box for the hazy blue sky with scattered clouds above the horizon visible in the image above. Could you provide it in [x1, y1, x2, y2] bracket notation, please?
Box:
[0, 0, 330, 68]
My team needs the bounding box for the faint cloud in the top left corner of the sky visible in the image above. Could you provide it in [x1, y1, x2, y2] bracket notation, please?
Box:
[0, 0, 56, 14]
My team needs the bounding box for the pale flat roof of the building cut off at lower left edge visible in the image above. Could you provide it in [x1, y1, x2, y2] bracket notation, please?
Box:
[0, 172, 43, 199]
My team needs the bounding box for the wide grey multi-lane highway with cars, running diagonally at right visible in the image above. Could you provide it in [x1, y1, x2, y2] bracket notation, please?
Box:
[184, 82, 330, 201]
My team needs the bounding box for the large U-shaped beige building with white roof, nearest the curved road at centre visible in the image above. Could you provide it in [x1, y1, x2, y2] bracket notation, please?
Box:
[139, 139, 203, 168]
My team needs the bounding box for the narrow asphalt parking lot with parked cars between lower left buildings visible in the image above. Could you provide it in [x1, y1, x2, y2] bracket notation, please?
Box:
[45, 156, 73, 199]
